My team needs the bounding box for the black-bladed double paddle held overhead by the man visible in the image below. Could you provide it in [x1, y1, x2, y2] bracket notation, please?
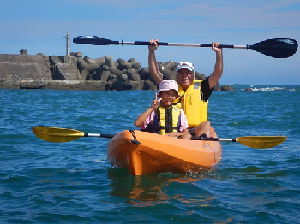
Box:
[73, 36, 298, 58]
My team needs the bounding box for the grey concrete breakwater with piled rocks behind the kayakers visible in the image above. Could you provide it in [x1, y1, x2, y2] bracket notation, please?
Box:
[0, 49, 233, 91]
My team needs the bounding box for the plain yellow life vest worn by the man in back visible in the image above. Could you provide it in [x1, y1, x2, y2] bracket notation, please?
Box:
[175, 80, 208, 127]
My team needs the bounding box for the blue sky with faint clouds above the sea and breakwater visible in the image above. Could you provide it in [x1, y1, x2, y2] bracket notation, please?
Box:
[0, 0, 300, 85]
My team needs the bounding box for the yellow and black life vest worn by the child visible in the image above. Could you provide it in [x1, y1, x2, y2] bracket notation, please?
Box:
[158, 106, 181, 135]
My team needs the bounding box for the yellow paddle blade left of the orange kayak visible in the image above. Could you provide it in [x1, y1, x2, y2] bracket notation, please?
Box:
[32, 127, 84, 142]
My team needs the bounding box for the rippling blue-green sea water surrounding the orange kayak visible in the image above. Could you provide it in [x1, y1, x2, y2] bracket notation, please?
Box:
[0, 85, 300, 223]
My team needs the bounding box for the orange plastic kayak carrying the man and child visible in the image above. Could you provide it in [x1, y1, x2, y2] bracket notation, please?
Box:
[107, 129, 222, 175]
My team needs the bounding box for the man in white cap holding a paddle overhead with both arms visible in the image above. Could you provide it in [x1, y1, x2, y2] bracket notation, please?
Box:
[148, 39, 224, 138]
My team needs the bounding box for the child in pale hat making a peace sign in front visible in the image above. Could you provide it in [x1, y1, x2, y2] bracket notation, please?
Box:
[135, 80, 191, 139]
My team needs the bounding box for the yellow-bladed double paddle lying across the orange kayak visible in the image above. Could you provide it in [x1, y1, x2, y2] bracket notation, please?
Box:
[33, 127, 287, 149]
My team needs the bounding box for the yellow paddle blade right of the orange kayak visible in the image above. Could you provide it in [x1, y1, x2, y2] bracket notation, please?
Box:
[236, 136, 287, 149]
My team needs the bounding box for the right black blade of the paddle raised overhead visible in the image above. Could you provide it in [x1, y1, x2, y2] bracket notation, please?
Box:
[248, 38, 298, 58]
